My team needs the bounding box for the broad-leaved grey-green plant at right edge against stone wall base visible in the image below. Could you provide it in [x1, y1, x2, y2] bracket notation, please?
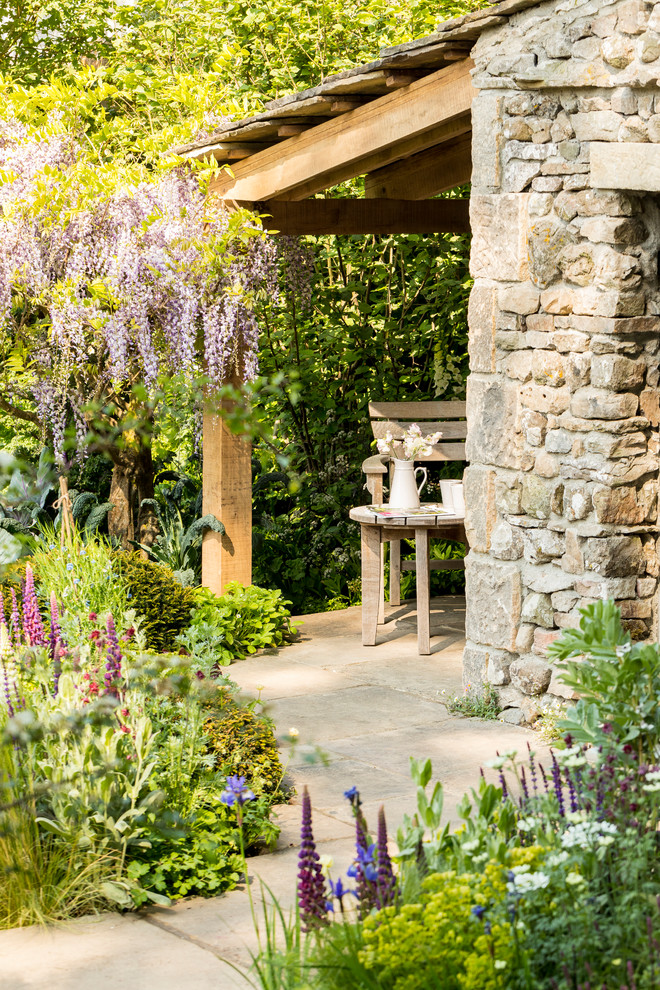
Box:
[549, 600, 660, 763]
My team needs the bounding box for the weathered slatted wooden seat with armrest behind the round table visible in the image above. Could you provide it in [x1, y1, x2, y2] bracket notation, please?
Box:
[362, 401, 467, 605]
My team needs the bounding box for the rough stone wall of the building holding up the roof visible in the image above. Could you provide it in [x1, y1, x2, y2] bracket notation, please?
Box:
[464, 0, 660, 722]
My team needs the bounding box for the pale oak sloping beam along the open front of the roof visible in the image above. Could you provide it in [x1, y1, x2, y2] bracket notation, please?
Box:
[209, 59, 475, 202]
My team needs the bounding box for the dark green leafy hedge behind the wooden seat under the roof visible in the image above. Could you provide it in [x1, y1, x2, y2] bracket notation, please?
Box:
[253, 235, 471, 612]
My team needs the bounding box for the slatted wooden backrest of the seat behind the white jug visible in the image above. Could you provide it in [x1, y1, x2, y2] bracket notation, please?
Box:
[369, 402, 467, 461]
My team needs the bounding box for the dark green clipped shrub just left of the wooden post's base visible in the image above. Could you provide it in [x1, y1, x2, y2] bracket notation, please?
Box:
[115, 551, 194, 652]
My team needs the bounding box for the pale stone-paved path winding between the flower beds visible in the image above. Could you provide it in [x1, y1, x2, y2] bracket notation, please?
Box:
[0, 598, 538, 990]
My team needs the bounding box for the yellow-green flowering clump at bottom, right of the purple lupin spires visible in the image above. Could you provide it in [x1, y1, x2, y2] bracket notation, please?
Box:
[360, 847, 540, 990]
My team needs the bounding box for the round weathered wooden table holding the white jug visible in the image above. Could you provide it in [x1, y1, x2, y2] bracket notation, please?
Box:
[350, 503, 465, 656]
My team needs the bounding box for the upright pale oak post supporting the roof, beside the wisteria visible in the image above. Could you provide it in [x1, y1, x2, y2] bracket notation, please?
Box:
[202, 398, 252, 595]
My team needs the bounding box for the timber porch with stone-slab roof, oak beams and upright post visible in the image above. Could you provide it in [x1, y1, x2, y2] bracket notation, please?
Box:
[193, 37, 482, 593]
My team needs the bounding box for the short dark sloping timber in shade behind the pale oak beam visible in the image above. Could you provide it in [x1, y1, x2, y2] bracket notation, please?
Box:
[364, 134, 472, 200]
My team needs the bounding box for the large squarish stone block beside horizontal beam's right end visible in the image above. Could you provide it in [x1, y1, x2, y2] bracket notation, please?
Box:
[470, 193, 529, 282]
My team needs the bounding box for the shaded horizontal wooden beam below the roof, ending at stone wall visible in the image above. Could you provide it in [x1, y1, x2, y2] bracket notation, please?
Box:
[259, 199, 470, 234]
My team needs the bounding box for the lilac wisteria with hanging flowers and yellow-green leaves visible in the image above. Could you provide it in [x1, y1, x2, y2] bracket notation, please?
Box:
[0, 118, 282, 456]
